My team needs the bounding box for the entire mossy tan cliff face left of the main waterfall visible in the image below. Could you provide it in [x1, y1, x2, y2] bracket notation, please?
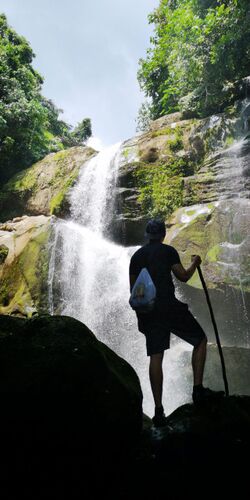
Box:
[0, 147, 96, 316]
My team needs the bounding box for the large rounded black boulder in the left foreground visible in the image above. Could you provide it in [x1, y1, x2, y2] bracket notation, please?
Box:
[0, 316, 142, 493]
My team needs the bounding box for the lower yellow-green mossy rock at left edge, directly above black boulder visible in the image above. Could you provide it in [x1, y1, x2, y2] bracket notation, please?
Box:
[0, 216, 50, 317]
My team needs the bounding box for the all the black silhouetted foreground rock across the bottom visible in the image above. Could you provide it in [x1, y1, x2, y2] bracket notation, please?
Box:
[0, 316, 250, 500]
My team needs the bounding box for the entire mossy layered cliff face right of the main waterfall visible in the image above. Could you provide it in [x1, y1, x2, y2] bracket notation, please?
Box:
[112, 99, 250, 345]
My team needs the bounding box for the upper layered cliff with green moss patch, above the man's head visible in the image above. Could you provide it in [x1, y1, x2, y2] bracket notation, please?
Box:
[118, 103, 250, 244]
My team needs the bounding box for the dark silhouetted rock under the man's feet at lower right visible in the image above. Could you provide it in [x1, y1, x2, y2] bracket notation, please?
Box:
[144, 396, 250, 500]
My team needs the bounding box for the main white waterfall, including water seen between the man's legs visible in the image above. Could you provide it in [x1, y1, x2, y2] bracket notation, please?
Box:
[49, 145, 191, 415]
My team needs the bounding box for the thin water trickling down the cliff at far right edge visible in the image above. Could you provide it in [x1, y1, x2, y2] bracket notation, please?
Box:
[209, 99, 250, 347]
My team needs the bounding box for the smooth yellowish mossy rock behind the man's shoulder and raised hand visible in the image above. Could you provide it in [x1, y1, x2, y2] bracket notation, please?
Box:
[165, 201, 250, 292]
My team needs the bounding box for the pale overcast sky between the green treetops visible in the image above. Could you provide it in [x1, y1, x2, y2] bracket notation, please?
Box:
[0, 0, 159, 145]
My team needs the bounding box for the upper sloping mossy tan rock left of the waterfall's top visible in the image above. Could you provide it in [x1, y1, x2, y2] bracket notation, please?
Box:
[0, 146, 96, 221]
